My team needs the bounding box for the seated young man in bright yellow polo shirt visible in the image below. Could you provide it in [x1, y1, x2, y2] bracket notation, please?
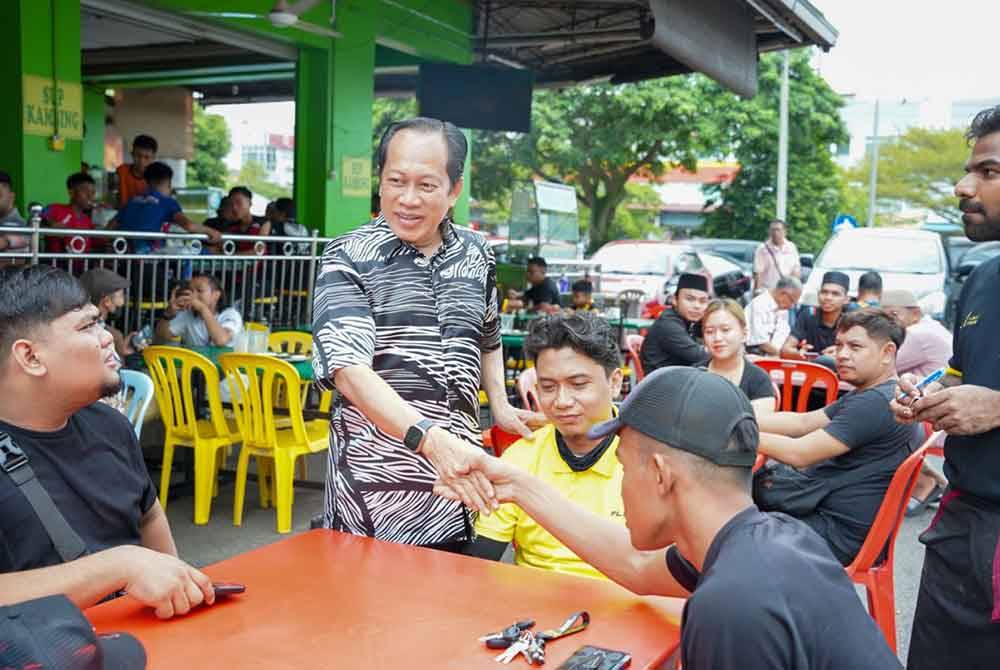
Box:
[466, 312, 625, 578]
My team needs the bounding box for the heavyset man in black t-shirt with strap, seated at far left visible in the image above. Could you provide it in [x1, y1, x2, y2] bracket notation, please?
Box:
[0, 265, 215, 618]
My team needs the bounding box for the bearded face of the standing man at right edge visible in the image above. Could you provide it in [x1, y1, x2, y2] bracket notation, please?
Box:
[955, 133, 1000, 242]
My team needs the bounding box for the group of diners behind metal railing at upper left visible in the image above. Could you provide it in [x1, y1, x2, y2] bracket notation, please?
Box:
[0, 135, 307, 262]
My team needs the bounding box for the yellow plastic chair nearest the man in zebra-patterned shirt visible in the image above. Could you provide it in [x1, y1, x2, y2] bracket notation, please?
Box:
[219, 354, 328, 533]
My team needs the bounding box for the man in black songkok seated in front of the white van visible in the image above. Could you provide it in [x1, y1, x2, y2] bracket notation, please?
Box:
[781, 270, 851, 367]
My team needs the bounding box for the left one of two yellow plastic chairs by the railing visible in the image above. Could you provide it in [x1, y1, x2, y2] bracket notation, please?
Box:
[142, 346, 240, 524]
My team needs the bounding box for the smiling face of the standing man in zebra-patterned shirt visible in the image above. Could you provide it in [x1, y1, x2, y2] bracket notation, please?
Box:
[379, 129, 462, 248]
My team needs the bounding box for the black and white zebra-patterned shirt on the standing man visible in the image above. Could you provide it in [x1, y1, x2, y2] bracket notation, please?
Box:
[313, 216, 500, 544]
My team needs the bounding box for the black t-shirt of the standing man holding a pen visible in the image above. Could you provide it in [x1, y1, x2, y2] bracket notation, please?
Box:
[944, 257, 1000, 504]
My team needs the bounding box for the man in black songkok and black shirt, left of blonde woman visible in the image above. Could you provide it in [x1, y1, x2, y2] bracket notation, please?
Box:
[639, 272, 710, 374]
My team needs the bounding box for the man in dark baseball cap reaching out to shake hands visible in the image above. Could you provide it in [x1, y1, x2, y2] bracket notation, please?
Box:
[435, 367, 900, 670]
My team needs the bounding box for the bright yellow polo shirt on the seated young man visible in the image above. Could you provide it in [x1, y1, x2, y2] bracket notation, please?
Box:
[476, 424, 625, 578]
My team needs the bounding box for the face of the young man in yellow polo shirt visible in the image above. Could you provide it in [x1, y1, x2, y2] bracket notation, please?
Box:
[535, 347, 622, 446]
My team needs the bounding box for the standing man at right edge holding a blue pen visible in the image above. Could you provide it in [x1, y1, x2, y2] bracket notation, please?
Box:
[893, 106, 1000, 670]
